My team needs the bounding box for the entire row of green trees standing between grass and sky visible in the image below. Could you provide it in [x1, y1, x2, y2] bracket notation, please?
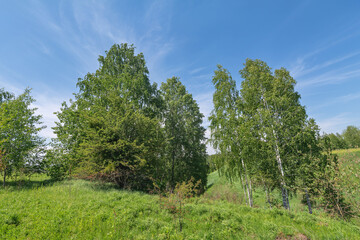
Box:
[0, 44, 358, 218]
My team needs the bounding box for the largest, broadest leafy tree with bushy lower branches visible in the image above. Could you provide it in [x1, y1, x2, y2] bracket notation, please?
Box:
[55, 44, 161, 186]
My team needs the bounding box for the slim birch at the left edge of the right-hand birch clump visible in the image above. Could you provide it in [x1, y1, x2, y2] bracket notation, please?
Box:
[209, 65, 253, 206]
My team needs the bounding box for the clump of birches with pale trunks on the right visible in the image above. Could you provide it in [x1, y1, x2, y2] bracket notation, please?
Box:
[209, 59, 345, 217]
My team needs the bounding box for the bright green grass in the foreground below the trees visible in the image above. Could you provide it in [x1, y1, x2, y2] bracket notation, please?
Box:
[0, 175, 360, 239]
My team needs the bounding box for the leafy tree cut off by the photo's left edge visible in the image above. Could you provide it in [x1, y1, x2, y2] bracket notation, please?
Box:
[0, 89, 44, 186]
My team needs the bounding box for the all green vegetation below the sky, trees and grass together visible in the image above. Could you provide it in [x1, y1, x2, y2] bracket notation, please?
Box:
[0, 44, 360, 239]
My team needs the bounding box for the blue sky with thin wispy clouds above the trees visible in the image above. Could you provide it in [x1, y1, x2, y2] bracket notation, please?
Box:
[0, 0, 360, 152]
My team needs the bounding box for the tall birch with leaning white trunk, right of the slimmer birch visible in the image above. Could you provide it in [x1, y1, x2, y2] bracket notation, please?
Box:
[240, 59, 307, 209]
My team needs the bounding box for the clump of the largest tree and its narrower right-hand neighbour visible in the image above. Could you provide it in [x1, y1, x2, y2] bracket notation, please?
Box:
[52, 44, 206, 191]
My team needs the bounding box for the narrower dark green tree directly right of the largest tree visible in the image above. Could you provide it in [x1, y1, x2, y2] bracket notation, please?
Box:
[160, 77, 207, 191]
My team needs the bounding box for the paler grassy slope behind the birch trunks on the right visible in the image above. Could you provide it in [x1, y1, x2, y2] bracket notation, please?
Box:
[205, 148, 360, 221]
